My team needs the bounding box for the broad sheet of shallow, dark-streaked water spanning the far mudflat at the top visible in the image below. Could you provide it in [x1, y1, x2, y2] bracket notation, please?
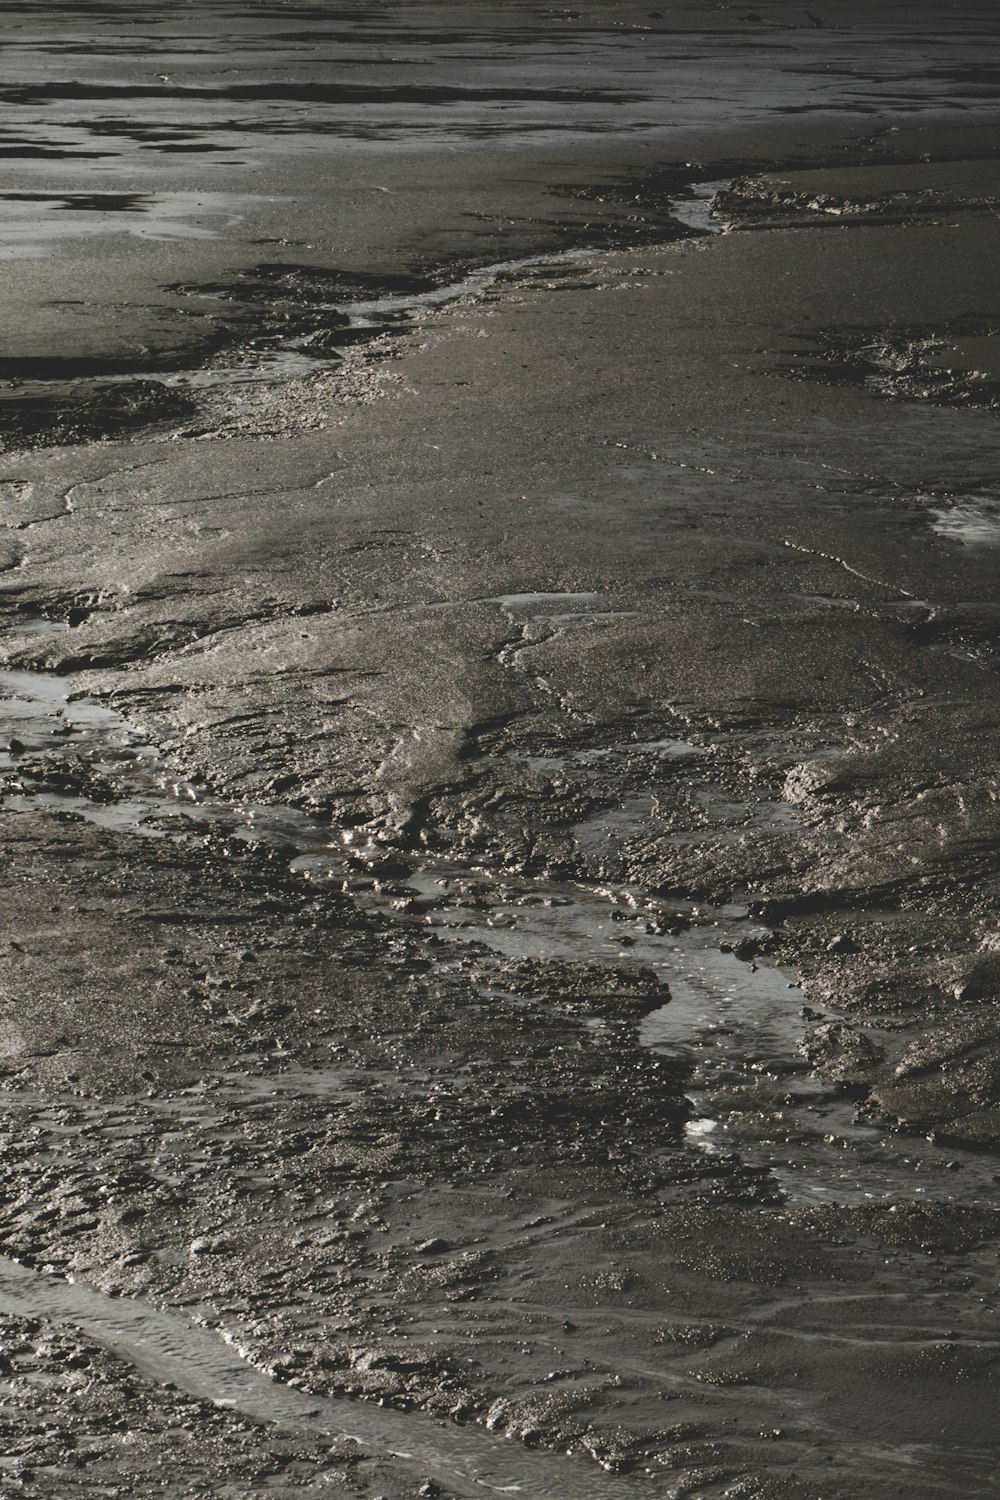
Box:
[0, 5, 993, 267]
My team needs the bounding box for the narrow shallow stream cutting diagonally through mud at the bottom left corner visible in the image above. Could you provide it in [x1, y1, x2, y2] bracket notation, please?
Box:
[0, 1257, 640, 1500]
